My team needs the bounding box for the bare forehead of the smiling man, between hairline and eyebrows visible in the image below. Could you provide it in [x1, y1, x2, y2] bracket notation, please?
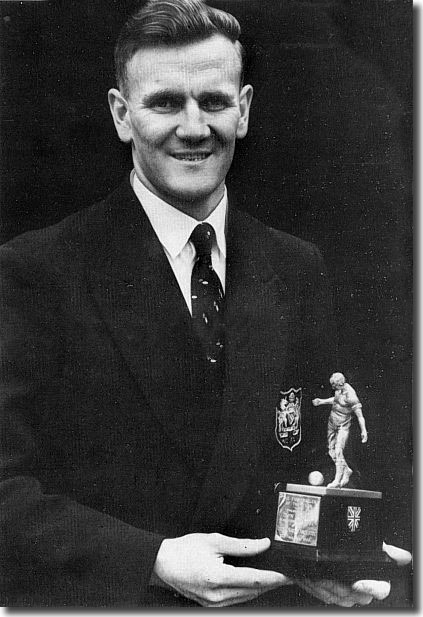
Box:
[128, 35, 241, 91]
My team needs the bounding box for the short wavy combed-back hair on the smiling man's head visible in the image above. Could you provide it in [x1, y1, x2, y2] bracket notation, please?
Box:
[115, 0, 245, 96]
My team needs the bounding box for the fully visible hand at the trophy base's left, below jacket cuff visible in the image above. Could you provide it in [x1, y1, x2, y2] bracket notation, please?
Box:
[153, 533, 291, 607]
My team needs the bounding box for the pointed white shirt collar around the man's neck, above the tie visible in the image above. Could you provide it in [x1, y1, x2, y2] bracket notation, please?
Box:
[131, 170, 228, 259]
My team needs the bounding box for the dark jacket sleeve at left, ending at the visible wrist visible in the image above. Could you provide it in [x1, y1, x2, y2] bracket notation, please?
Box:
[0, 246, 163, 607]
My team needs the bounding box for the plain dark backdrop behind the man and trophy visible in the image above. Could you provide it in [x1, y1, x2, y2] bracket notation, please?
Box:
[0, 0, 412, 596]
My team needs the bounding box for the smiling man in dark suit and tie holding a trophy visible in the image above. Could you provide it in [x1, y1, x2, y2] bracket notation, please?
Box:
[1, 0, 408, 607]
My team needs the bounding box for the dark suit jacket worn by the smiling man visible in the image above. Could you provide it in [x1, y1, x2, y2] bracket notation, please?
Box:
[0, 178, 336, 607]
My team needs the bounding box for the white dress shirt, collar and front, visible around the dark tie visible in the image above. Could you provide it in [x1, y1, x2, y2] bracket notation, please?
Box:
[131, 170, 228, 314]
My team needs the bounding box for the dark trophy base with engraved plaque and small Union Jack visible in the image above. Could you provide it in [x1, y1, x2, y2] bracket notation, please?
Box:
[267, 484, 397, 581]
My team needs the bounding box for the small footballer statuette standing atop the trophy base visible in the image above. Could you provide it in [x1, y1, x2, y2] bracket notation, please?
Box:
[312, 373, 367, 488]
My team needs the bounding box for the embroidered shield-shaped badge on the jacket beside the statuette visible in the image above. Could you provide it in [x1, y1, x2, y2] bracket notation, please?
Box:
[275, 388, 302, 452]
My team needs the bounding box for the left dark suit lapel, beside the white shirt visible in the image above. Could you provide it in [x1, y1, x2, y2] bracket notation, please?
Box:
[89, 183, 202, 445]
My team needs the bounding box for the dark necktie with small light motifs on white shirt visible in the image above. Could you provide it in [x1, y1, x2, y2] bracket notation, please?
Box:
[190, 223, 224, 364]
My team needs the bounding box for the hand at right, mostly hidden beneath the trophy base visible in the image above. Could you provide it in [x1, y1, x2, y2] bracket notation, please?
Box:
[294, 543, 411, 607]
